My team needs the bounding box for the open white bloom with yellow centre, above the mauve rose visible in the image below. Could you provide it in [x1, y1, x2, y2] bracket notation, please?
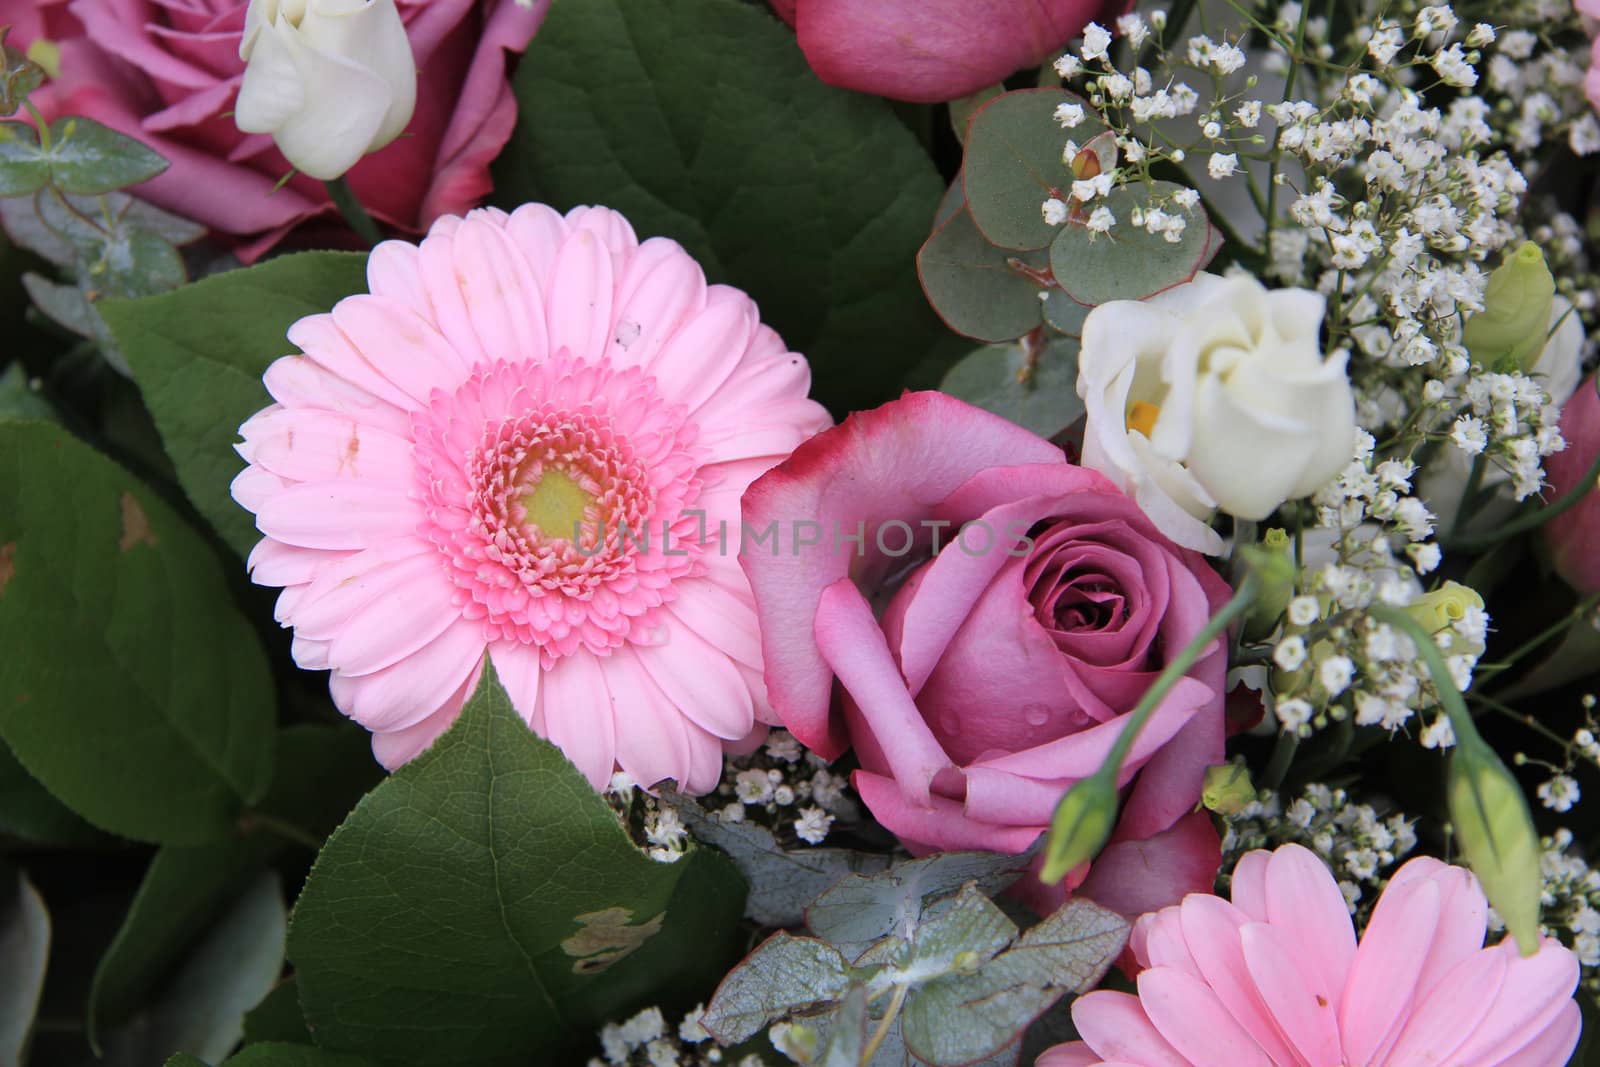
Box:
[1078, 274, 1355, 555]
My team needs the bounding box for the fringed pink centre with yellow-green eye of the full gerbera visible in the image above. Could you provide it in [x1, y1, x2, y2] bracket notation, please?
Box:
[413, 354, 702, 664]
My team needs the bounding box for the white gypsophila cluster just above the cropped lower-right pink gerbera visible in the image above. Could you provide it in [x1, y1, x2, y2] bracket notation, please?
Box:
[1219, 782, 1416, 925]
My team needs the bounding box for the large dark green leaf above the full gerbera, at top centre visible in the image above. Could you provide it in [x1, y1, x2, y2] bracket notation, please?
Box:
[494, 0, 947, 410]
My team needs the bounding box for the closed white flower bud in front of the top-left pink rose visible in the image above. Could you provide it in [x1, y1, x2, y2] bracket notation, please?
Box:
[234, 0, 416, 181]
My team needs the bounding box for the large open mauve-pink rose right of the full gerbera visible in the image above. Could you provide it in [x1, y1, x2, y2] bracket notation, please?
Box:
[739, 392, 1229, 915]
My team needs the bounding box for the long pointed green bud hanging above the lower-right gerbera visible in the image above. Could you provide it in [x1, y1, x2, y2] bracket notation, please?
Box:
[1448, 734, 1544, 957]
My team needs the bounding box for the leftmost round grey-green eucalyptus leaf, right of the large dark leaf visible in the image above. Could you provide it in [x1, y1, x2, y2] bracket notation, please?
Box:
[917, 202, 1050, 341]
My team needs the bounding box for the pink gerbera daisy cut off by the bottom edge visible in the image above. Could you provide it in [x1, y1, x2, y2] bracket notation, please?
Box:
[1038, 845, 1579, 1067]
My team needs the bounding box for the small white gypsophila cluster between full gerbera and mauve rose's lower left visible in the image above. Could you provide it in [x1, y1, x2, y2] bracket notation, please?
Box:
[704, 729, 861, 845]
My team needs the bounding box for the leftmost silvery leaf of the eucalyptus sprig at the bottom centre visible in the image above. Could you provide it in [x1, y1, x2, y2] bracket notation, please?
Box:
[701, 931, 850, 1045]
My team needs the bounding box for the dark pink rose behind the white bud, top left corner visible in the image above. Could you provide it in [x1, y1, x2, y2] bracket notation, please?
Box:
[0, 0, 549, 262]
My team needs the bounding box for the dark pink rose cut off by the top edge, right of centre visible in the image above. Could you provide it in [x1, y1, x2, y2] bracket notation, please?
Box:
[771, 0, 1130, 104]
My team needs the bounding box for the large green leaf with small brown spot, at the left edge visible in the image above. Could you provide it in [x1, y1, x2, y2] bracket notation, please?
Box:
[0, 422, 274, 845]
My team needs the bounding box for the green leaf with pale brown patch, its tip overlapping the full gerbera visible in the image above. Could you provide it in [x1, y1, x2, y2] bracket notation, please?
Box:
[290, 667, 744, 1067]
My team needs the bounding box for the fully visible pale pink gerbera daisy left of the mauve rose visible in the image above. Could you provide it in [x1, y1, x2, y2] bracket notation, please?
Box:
[234, 205, 827, 792]
